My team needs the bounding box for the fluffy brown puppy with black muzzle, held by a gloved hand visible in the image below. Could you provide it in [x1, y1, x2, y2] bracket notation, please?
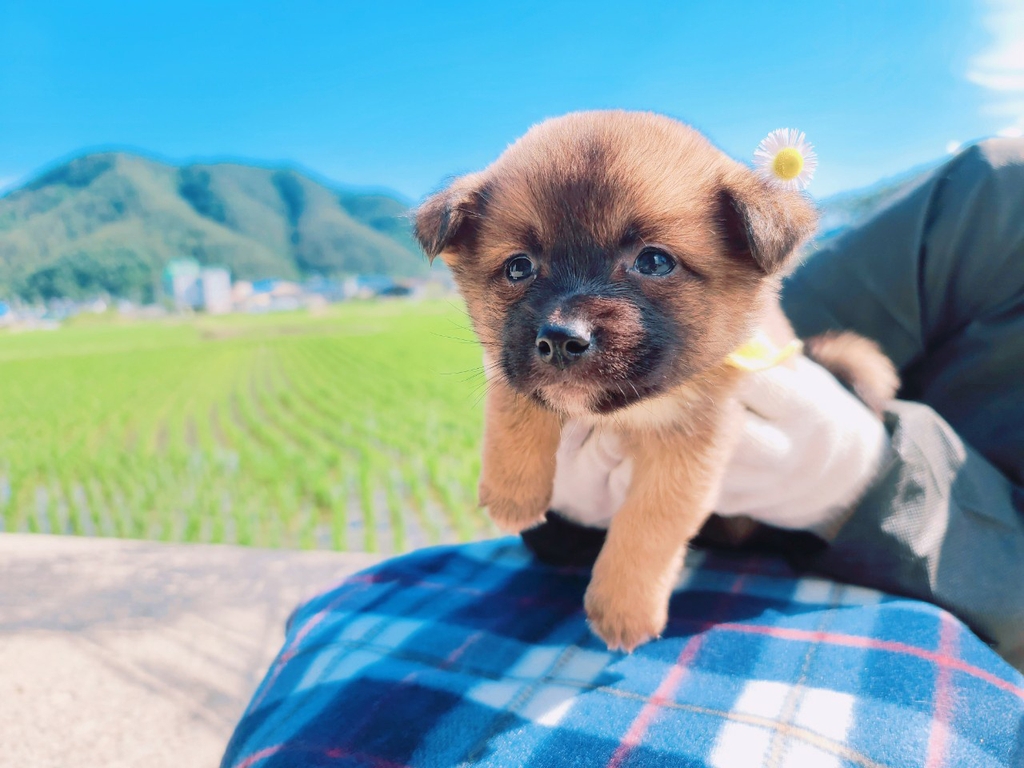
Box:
[416, 112, 895, 651]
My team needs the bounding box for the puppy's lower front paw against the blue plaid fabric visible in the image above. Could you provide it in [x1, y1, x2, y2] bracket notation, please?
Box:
[584, 581, 669, 653]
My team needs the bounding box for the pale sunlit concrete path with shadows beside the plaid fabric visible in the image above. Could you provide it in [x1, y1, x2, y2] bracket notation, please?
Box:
[0, 534, 378, 768]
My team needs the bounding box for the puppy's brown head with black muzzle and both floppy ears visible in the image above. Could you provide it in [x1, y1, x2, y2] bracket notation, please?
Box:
[416, 112, 815, 416]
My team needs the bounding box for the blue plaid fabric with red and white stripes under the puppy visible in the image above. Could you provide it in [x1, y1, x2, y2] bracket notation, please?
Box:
[222, 539, 1024, 768]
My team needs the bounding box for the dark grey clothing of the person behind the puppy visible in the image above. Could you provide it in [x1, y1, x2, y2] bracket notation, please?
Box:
[782, 139, 1024, 671]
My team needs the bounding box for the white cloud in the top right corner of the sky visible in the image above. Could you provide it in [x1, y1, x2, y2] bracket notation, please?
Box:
[967, 0, 1024, 135]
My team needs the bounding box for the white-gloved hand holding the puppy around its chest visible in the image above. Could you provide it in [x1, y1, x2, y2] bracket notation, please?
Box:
[550, 356, 889, 535]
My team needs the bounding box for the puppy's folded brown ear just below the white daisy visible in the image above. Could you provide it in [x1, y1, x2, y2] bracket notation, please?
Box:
[718, 168, 818, 274]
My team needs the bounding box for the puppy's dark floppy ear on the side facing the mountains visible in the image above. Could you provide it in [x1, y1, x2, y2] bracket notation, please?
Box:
[416, 174, 483, 262]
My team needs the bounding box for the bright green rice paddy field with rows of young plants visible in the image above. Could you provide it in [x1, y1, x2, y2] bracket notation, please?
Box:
[0, 301, 494, 552]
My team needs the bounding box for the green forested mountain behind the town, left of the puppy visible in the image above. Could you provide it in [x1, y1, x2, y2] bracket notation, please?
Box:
[0, 153, 427, 300]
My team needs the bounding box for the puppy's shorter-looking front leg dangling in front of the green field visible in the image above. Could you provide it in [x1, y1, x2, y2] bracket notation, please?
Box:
[479, 380, 561, 534]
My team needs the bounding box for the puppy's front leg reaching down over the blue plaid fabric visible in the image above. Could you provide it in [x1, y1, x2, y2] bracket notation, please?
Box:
[584, 423, 723, 651]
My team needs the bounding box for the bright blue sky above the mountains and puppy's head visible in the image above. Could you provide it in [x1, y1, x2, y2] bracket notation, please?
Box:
[0, 0, 1024, 200]
